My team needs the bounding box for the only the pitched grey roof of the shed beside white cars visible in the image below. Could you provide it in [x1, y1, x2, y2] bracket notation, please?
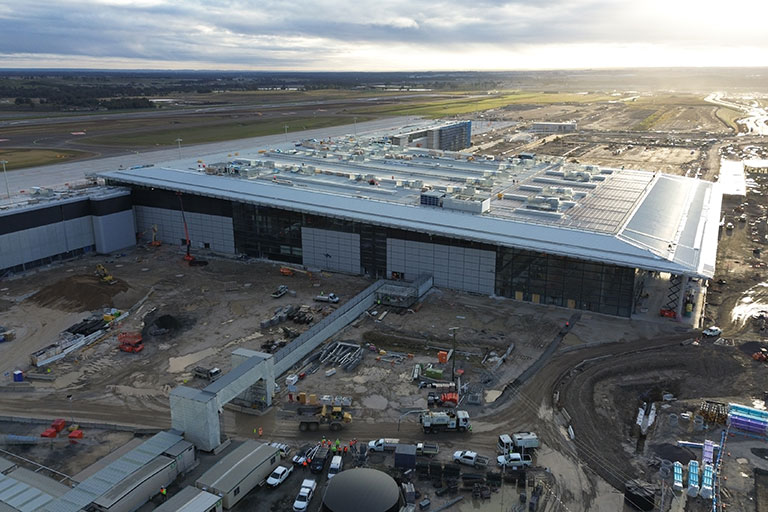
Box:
[195, 440, 280, 494]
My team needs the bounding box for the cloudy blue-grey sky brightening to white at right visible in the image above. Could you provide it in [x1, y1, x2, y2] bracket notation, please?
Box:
[0, 0, 768, 71]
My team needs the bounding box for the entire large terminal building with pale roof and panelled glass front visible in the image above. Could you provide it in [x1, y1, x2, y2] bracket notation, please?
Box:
[90, 136, 722, 317]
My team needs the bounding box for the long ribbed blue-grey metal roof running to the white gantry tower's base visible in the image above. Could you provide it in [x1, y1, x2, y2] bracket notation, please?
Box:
[38, 432, 183, 512]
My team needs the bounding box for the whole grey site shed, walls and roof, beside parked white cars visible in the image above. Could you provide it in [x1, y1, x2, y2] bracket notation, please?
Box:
[195, 441, 280, 509]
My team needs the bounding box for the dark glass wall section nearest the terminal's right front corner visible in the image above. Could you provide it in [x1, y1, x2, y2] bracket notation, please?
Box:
[496, 247, 635, 317]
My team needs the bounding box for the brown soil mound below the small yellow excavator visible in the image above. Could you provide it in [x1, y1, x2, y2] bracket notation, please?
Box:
[27, 275, 130, 312]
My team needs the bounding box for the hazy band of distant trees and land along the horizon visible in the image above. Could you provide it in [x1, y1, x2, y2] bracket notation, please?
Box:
[0, 68, 768, 110]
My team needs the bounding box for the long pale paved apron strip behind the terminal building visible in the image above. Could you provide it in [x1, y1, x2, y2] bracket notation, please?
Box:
[0, 117, 419, 204]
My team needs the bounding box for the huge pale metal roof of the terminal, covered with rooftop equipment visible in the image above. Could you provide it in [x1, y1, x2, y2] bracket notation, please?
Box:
[100, 145, 722, 277]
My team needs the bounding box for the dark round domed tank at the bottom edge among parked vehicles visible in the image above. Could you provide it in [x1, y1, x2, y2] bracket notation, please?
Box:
[321, 468, 402, 512]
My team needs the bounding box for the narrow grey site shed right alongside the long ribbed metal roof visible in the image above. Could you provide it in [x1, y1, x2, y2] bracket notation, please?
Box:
[93, 455, 179, 512]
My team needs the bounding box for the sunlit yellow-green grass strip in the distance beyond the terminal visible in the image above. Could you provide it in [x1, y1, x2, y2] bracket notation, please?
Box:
[351, 92, 610, 118]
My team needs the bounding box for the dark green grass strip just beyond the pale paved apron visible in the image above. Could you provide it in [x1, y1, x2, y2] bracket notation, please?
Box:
[82, 116, 375, 146]
